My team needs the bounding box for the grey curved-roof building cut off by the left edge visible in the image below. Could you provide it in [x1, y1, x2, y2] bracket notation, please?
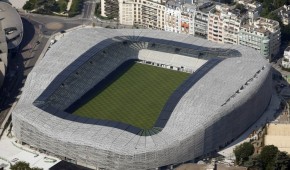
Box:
[0, 2, 23, 87]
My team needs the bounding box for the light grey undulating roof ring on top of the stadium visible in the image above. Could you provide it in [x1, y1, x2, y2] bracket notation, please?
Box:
[13, 28, 270, 161]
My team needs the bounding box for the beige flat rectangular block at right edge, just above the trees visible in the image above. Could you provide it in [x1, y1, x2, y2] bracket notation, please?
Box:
[264, 123, 290, 154]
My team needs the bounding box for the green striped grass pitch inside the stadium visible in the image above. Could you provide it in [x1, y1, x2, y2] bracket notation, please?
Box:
[73, 63, 190, 129]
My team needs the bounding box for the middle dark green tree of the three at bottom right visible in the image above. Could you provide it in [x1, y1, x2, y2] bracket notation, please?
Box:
[259, 145, 279, 169]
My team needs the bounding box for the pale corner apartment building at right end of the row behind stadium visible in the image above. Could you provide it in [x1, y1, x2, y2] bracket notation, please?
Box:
[239, 17, 281, 60]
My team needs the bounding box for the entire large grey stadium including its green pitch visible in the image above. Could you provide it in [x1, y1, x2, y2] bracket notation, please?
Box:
[12, 28, 272, 170]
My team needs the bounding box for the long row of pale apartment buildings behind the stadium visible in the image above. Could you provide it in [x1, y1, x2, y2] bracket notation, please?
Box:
[102, 0, 280, 59]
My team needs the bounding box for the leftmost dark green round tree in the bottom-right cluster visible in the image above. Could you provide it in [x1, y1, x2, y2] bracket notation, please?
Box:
[234, 142, 254, 165]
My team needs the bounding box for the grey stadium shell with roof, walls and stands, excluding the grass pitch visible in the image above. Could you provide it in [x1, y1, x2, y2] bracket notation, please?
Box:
[12, 28, 272, 169]
